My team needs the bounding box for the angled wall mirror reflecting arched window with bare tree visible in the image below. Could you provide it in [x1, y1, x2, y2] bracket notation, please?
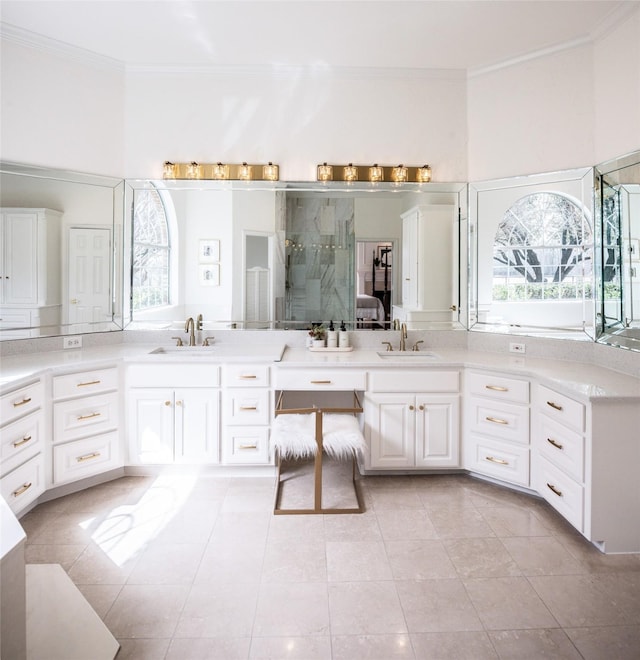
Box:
[469, 168, 598, 340]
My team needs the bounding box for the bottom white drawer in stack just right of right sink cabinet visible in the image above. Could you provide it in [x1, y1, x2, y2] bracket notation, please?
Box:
[465, 433, 529, 486]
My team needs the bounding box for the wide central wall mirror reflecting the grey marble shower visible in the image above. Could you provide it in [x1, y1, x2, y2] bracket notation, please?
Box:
[125, 180, 467, 330]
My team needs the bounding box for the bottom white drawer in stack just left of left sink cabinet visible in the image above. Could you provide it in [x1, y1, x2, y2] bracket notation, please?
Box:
[53, 431, 120, 484]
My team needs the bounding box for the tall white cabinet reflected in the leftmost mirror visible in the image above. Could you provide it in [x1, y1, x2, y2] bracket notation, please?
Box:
[0, 208, 62, 339]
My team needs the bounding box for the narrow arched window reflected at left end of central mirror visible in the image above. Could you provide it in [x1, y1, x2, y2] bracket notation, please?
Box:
[132, 188, 171, 311]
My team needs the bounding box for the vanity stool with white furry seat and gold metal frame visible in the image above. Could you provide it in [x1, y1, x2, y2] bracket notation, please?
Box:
[271, 392, 365, 515]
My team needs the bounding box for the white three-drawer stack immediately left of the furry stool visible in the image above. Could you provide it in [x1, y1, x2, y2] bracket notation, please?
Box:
[222, 364, 273, 465]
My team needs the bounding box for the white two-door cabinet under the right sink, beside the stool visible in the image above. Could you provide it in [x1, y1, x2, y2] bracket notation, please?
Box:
[364, 369, 460, 470]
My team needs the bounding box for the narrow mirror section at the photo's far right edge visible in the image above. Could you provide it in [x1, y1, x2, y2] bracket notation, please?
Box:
[595, 151, 640, 351]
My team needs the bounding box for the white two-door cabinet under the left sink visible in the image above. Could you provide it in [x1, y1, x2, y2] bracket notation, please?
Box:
[127, 364, 220, 464]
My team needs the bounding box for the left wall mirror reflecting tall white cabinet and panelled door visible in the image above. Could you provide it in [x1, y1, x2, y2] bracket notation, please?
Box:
[0, 163, 124, 340]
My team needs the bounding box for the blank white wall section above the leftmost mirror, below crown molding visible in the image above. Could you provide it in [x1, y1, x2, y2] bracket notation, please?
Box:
[0, 39, 125, 177]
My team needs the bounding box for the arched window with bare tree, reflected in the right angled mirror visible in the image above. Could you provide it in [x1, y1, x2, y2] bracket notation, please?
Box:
[493, 192, 593, 301]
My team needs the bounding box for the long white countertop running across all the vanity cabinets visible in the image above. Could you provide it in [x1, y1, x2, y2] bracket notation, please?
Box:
[0, 343, 640, 401]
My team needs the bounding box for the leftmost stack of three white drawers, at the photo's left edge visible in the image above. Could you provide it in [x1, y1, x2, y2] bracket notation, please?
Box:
[0, 380, 45, 513]
